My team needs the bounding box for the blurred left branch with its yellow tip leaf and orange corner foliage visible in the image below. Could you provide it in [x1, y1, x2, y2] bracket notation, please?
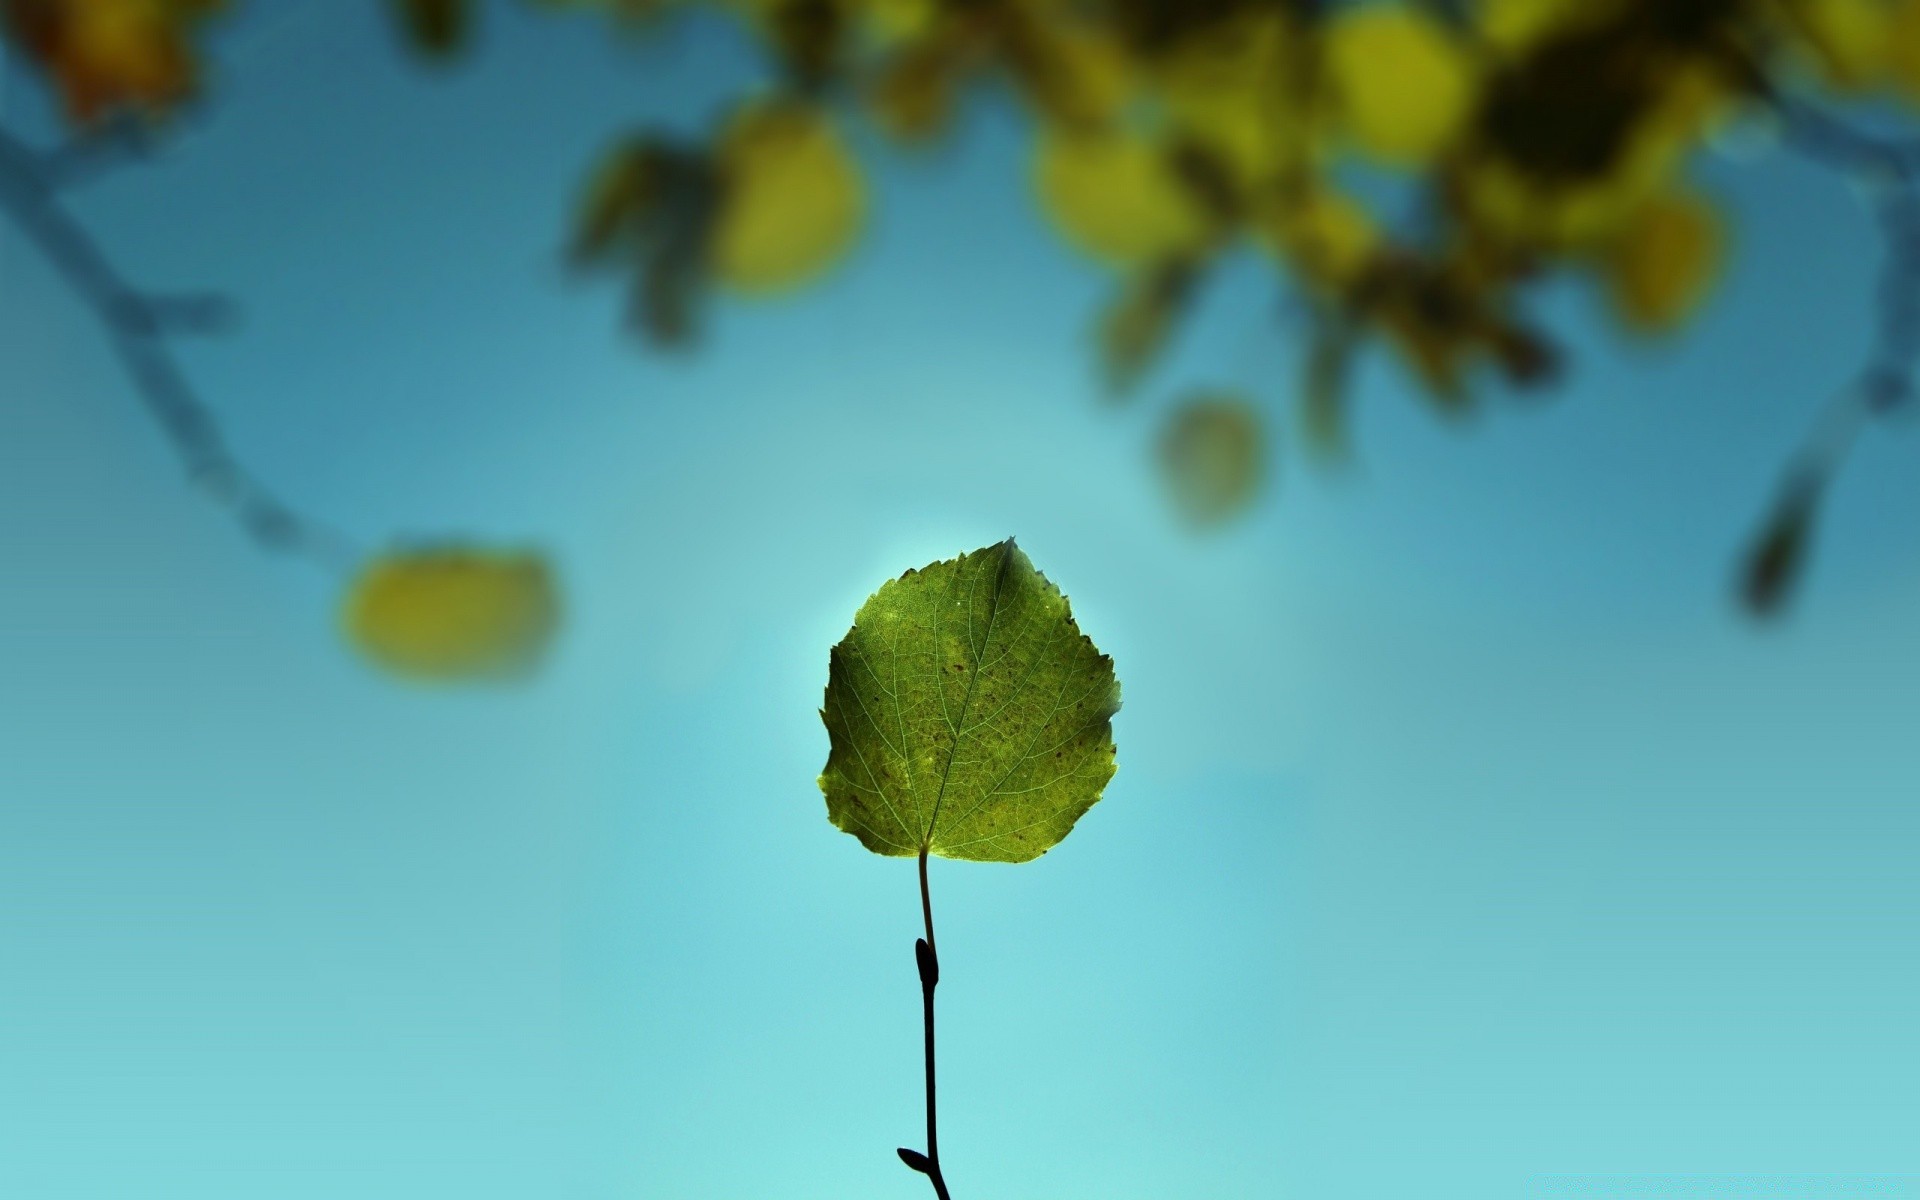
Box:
[0, 18, 561, 682]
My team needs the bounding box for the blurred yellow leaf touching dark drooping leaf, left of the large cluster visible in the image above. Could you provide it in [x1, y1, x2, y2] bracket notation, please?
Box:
[710, 100, 866, 292]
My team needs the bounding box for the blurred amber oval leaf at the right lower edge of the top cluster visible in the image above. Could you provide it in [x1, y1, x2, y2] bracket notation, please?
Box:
[1601, 190, 1724, 332]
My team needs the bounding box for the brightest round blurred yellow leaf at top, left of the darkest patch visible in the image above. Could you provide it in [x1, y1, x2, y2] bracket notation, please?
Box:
[1325, 4, 1475, 167]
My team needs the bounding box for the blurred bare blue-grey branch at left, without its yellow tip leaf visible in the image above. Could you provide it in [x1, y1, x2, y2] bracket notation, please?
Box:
[0, 129, 357, 566]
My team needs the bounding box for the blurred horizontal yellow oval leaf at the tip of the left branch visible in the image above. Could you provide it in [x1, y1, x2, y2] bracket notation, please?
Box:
[342, 547, 559, 682]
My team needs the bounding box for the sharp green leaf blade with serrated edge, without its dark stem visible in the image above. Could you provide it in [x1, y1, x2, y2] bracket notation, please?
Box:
[820, 540, 1119, 862]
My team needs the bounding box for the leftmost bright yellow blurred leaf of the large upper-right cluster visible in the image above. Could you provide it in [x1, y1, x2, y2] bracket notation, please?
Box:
[1037, 129, 1212, 265]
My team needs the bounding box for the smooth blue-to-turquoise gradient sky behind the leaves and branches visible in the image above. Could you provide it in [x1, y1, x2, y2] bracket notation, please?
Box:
[0, 4, 1920, 1200]
